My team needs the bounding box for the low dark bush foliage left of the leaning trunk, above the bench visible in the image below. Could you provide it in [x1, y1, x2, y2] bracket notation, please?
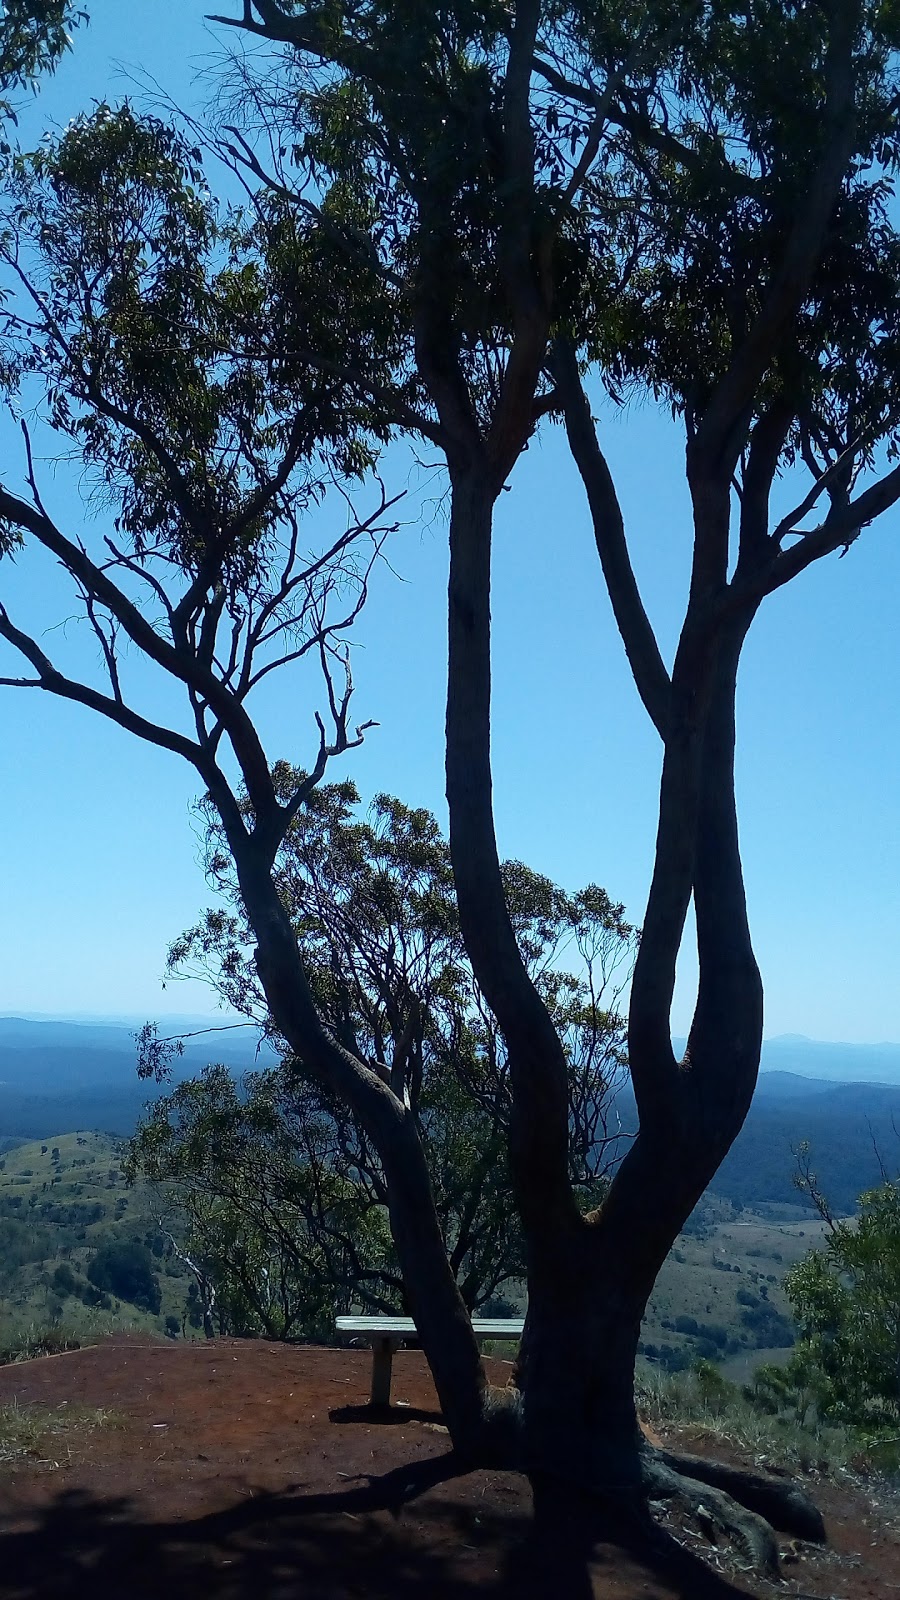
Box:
[127, 1067, 392, 1339]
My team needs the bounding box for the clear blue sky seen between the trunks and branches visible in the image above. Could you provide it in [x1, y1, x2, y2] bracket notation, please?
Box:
[0, 0, 900, 1042]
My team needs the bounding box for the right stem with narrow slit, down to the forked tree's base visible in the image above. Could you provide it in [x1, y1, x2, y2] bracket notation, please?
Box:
[506, 537, 762, 1488]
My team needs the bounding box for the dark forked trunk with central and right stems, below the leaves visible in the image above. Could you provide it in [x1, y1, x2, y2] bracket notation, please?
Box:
[447, 470, 778, 1510]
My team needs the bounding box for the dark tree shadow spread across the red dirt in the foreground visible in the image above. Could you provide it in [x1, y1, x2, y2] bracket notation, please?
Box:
[0, 1454, 755, 1600]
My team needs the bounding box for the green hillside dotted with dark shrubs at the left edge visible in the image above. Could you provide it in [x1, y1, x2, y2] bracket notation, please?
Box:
[0, 1133, 192, 1354]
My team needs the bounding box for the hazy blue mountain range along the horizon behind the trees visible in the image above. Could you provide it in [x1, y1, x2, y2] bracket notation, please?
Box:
[0, 1016, 900, 1210]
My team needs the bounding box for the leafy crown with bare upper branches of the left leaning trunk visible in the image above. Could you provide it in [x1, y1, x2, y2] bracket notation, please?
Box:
[0, 104, 396, 851]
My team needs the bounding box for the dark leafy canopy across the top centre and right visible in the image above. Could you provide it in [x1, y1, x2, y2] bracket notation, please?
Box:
[209, 0, 900, 486]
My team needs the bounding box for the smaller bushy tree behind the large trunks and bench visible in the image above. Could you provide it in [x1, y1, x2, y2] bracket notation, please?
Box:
[130, 780, 634, 1338]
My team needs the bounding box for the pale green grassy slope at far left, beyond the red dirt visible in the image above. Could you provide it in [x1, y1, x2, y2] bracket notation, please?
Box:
[0, 1133, 194, 1349]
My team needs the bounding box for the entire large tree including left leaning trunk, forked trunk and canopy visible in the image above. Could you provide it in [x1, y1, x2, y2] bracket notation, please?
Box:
[0, 0, 900, 1562]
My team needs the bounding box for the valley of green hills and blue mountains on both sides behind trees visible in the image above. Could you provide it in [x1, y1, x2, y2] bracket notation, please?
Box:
[0, 1018, 883, 1382]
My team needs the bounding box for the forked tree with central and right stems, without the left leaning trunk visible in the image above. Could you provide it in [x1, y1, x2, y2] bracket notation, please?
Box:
[188, 0, 900, 1560]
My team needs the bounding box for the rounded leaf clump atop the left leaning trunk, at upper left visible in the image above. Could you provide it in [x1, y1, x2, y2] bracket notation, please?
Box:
[3, 104, 377, 560]
